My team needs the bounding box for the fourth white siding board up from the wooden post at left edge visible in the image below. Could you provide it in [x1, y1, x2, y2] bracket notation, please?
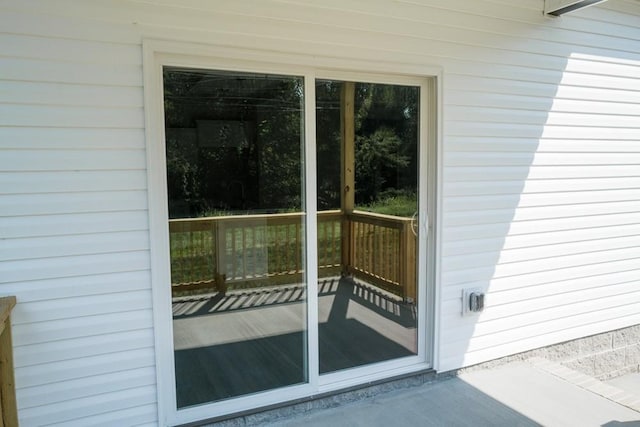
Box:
[0, 211, 149, 239]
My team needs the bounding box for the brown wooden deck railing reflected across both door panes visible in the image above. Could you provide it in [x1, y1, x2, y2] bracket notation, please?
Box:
[169, 210, 415, 298]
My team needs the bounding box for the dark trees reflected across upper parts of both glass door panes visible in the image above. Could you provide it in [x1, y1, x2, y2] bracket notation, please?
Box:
[164, 68, 419, 218]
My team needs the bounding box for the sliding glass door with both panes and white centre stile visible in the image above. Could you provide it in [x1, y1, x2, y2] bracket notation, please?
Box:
[162, 66, 427, 412]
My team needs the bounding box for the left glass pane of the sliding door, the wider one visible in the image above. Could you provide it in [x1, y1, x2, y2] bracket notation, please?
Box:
[164, 68, 307, 408]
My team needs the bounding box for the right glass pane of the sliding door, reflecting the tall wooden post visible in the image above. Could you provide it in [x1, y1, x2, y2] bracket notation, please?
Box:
[316, 80, 420, 373]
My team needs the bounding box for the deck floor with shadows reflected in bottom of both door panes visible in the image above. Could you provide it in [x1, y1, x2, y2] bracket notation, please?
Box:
[173, 278, 417, 407]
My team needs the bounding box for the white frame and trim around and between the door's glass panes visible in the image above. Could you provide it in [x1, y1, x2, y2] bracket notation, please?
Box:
[143, 40, 442, 425]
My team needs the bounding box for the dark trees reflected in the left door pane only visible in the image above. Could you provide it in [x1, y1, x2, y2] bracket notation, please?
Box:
[164, 68, 304, 218]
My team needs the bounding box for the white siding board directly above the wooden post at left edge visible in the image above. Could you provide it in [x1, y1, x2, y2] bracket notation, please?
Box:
[0, 271, 151, 304]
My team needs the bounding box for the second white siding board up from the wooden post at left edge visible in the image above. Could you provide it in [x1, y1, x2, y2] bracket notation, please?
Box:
[0, 251, 149, 284]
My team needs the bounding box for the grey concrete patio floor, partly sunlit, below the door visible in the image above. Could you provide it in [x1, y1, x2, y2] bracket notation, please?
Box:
[262, 359, 640, 427]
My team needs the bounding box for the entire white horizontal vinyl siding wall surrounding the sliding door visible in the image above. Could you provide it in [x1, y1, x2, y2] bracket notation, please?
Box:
[0, 0, 640, 426]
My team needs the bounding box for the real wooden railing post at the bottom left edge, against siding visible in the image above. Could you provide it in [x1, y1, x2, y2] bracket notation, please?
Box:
[0, 297, 18, 427]
